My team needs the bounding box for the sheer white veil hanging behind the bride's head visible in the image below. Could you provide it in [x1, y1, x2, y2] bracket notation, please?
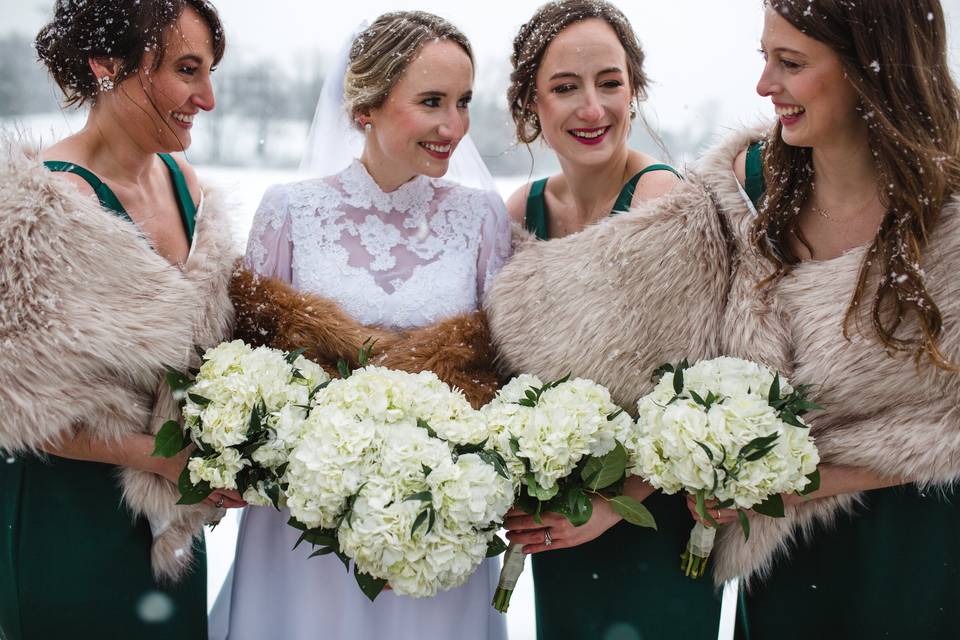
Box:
[300, 22, 497, 193]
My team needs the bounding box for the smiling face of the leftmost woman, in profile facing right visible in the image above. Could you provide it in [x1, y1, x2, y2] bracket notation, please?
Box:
[109, 7, 214, 152]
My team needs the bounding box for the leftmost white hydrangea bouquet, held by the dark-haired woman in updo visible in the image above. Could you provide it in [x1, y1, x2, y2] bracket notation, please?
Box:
[154, 340, 330, 508]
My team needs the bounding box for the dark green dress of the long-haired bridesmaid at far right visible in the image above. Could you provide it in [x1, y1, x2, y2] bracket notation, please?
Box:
[737, 144, 960, 640]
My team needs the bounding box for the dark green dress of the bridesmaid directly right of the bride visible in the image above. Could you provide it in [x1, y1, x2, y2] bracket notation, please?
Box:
[525, 164, 720, 640]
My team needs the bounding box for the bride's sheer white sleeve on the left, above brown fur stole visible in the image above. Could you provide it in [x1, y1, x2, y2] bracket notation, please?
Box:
[244, 185, 293, 283]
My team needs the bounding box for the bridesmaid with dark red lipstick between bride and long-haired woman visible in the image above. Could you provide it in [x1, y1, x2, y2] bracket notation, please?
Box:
[505, 0, 719, 640]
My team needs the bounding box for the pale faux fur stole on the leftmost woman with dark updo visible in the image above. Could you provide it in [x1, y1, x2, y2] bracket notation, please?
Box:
[0, 134, 235, 580]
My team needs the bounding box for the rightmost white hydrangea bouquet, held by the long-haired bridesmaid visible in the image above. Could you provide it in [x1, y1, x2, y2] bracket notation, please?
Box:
[637, 357, 820, 578]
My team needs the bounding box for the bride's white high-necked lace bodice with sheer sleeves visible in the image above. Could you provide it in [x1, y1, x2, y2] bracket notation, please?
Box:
[246, 161, 510, 328]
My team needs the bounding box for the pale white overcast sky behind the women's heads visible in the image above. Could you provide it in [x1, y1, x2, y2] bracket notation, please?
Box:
[0, 0, 960, 128]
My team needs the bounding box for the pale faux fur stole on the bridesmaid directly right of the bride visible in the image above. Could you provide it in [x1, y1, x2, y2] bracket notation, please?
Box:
[484, 149, 731, 412]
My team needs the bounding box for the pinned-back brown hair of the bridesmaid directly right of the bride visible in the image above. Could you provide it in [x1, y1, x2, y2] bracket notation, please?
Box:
[507, 0, 648, 144]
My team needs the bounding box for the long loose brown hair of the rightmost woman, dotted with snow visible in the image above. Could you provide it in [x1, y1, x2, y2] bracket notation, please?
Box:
[753, 0, 960, 369]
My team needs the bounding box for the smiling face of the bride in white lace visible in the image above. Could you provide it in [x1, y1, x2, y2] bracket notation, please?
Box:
[361, 40, 473, 189]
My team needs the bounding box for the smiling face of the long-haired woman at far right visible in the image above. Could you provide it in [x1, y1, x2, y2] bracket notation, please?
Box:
[757, 8, 867, 147]
